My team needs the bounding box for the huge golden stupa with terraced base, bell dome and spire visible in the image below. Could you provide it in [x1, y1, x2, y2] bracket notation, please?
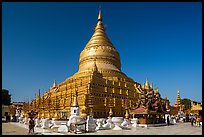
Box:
[30, 10, 142, 118]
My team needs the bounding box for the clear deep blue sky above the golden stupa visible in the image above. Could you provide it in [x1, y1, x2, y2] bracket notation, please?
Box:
[2, 2, 202, 105]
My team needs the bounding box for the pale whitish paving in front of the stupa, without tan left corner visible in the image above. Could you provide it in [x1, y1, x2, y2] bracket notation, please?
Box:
[8, 122, 202, 135]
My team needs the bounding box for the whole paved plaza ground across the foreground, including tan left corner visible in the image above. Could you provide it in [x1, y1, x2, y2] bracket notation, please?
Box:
[2, 122, 202, 135]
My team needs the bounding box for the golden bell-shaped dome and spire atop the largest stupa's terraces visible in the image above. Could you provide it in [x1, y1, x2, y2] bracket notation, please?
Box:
[79, 10, 121, 72]
